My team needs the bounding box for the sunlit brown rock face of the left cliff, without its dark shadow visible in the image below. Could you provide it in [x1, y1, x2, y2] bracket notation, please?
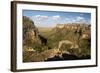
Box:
[23, 16, 41, 50]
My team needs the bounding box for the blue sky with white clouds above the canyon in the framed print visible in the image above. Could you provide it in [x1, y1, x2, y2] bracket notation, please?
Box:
[23, 10, 91, 27]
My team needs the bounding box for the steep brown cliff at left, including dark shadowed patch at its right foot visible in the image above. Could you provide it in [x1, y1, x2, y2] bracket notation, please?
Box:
[23, 16, 47, 51]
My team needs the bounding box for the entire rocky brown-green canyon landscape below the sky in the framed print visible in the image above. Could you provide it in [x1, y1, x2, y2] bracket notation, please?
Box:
[23, 16, 91, 62]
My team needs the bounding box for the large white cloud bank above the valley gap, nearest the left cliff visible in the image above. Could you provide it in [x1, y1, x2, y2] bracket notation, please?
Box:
[31, 15, 61, 26]
